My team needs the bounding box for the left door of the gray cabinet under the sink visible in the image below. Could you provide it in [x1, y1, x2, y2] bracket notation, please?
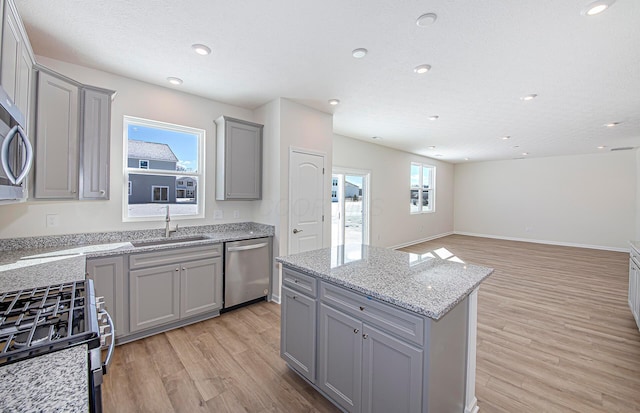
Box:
[129, 264, 180, 333]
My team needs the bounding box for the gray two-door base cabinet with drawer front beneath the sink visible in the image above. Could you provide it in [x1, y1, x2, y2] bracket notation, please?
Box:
[129, 244, 222, 333]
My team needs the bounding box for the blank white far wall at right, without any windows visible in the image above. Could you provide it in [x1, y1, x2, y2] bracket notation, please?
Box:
[454, 151, 637, 250]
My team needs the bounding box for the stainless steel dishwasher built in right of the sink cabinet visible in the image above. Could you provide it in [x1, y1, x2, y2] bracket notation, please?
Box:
[224, 237, 271, 309]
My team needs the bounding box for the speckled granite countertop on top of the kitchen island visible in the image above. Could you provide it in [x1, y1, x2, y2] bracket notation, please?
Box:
[276, 245, 493, 320]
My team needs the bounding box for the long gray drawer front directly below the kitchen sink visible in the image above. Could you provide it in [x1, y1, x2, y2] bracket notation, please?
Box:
[129, 244, 222, 270]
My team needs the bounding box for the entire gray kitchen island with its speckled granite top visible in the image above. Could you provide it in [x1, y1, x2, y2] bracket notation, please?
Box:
[277, 245, 493, 413]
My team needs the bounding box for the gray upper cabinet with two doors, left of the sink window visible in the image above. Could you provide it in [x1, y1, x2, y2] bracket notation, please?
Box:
[35, 66, 113, 199]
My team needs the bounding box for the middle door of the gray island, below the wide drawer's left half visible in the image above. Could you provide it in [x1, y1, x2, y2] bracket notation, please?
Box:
[318, 303, 362, 412]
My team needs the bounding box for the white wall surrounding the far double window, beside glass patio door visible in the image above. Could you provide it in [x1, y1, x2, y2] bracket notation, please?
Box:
[333, 135, 454, 247]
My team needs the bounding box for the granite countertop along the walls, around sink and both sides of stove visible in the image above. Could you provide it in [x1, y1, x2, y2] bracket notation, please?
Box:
[0, 223, 274, 412]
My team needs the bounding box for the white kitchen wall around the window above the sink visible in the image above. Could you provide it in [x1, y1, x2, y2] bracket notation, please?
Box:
[0, 56, 256, 238]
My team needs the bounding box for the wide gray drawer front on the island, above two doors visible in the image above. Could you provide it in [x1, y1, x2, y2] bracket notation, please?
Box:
[320, 281, 425, 346]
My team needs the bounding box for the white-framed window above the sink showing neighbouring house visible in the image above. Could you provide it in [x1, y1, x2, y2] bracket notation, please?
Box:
[122, 116, 205, 221]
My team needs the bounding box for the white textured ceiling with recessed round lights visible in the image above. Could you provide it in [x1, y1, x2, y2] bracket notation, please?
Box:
[16, 0, 640, 163]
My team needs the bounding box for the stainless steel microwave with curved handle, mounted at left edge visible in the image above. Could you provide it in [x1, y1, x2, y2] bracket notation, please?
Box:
[0, 86, 33, 204]
